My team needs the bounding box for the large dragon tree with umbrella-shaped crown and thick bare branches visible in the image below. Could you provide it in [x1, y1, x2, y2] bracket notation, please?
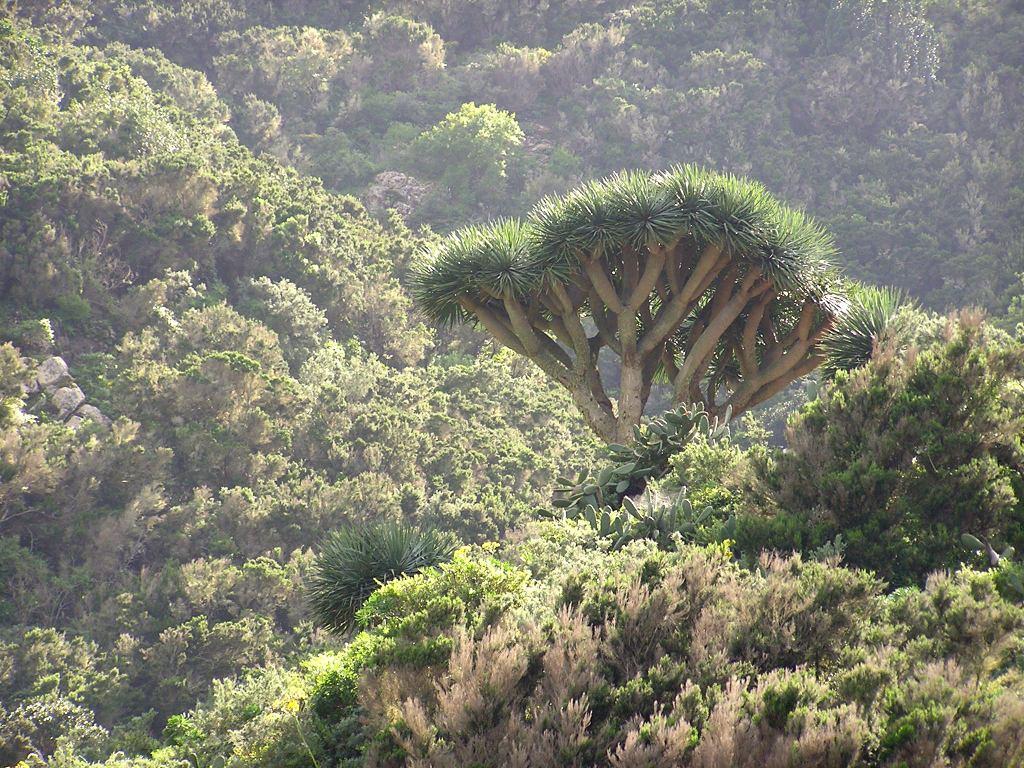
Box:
[414, 166, 846, 442]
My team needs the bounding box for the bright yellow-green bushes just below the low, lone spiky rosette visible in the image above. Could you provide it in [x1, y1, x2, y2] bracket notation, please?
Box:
[133, 550, 526, 768]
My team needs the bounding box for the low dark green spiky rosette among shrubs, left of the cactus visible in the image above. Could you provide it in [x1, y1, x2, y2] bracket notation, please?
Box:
[307, 522, 454, 631]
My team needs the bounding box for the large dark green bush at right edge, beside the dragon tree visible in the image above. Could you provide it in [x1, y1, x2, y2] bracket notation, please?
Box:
[737, 314, 1024, 585]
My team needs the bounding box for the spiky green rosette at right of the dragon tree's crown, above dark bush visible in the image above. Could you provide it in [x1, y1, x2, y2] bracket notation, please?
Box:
[821, 287, 910, 379]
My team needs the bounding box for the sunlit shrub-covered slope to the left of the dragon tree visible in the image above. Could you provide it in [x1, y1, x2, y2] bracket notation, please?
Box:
[0, 17, 592, 764]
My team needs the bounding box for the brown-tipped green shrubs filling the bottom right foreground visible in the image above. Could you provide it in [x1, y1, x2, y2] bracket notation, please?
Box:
[370, 544, 1024, 766]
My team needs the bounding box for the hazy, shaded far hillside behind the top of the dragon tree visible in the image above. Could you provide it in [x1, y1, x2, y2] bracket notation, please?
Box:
[18, 0, 1024, 312]
